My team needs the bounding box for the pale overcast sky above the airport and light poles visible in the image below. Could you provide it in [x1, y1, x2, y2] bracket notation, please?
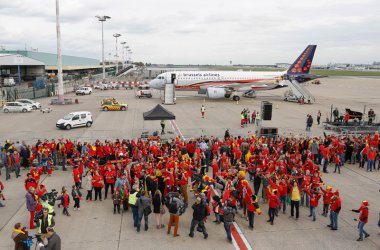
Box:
[0, 0, 380, 65]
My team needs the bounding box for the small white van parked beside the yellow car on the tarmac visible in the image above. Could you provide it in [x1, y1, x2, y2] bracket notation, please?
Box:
[56, 111, 92, 130]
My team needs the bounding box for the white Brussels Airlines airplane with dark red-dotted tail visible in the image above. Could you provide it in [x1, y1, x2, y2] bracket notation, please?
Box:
[149, 45, 318, 101]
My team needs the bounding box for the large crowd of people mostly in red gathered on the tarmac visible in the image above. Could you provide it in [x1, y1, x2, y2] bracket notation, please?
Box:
[0, 131, 380, 247]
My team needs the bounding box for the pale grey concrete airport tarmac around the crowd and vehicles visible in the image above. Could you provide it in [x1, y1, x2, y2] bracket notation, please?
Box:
[0, 77, 380, 250]
